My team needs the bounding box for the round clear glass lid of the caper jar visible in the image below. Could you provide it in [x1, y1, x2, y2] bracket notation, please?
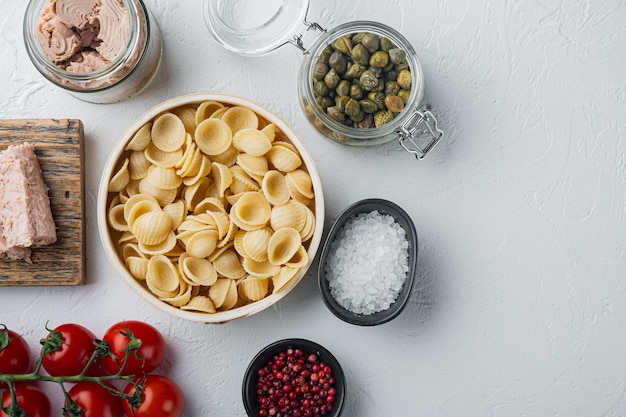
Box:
[204, 0, 309, 55]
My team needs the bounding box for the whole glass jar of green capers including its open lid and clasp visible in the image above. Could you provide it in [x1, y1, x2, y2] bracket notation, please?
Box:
[204, 0, 443, 159]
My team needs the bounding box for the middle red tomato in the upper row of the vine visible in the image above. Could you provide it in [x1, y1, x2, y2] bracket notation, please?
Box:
[43, 323, 96, 376]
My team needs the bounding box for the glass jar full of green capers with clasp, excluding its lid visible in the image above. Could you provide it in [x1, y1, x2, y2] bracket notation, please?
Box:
[299, 21, 442, 159]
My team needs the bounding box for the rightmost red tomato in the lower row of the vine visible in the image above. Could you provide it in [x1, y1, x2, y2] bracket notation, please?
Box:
[123, 375, 185, 417]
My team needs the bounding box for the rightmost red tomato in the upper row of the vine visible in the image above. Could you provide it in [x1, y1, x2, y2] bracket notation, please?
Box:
[102, 320, 165, 375]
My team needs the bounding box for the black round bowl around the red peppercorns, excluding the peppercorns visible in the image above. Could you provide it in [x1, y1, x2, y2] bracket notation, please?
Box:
[242, 339, 346, 417]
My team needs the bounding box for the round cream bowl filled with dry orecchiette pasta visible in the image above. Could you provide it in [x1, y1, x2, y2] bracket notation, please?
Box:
[98, 93, 324, 323]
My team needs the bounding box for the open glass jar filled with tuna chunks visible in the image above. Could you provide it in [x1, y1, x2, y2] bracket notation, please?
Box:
[24, 0, 162, 103]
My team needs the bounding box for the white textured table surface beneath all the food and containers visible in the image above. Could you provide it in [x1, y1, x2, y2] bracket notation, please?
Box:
[0, 0, 626, 417]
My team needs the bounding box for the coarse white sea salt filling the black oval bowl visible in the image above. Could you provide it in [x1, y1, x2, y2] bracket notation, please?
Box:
[325, 210, 409, 315]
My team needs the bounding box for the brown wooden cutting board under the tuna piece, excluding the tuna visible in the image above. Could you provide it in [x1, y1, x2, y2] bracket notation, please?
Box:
[0, 119, 85, 286]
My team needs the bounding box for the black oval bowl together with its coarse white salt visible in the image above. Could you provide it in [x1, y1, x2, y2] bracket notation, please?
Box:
[318, 198, 417, 326]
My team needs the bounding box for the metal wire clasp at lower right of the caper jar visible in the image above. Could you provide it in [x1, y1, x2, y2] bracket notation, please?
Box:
[396, 109, 443, 160]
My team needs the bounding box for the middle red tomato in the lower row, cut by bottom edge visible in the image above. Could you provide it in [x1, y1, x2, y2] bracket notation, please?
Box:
[65, 381, 124, 417]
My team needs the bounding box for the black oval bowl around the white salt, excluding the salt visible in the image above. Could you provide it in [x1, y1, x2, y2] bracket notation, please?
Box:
[317, 198, 417, 326]
